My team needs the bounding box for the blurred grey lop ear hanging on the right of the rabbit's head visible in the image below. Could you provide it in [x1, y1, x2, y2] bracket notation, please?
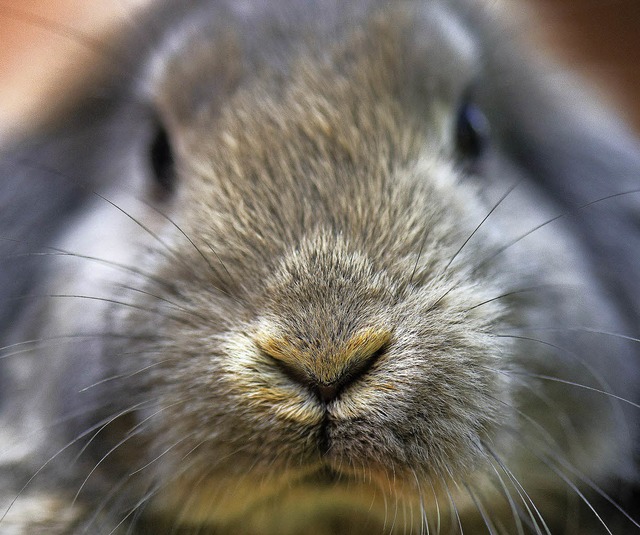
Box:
[483, 45, 640, 326]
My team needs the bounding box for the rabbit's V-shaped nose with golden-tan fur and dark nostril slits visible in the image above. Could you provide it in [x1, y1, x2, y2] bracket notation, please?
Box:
[255, 328, 391, 403]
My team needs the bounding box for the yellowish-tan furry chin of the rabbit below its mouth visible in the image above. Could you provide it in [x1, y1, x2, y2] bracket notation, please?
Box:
[149, 465, 473, 534]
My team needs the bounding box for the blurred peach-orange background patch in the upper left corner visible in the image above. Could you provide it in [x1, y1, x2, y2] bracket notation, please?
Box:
[0, 0, 145, 134]
